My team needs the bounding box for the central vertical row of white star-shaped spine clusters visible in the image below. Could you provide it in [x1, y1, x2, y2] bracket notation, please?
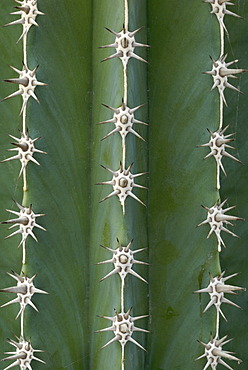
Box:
[97, 0, 149, 370]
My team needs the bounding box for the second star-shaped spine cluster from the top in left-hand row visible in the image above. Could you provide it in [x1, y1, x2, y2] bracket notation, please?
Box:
[2, 64, 46, 115]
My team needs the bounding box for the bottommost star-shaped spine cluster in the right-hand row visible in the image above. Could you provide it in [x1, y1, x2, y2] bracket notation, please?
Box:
[196, 335, 242, 370]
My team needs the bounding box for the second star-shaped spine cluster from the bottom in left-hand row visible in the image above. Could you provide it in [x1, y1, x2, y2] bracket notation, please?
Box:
[0, 272, 48, 318]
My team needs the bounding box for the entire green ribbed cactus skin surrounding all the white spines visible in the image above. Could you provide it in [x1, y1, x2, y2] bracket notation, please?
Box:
[0, 0, 248, 370]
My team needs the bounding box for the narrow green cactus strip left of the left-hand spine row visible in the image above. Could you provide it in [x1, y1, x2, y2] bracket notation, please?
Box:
[0, 13, 22, 350]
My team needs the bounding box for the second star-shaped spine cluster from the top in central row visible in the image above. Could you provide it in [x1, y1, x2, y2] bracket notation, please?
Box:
[98, 101, 148, 141]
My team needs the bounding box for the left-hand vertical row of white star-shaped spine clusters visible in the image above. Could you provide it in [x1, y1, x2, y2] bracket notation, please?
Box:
[0, 0, 47, 370]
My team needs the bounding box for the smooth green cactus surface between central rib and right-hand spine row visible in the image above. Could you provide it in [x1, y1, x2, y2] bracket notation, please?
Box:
[148, 1, 219, 370]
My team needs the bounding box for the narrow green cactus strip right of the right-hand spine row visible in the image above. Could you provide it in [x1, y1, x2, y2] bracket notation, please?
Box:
[220, 1, 248, 369]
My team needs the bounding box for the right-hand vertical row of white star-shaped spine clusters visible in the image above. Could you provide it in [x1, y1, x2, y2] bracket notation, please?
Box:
[198, 0, 247, 370]
